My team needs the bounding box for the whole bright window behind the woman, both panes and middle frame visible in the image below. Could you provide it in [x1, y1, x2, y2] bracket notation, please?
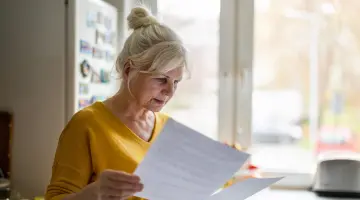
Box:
[135, 0, 360, 186]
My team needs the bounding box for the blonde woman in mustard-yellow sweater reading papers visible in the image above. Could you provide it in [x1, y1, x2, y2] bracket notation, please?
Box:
[46, 7, 186, 200]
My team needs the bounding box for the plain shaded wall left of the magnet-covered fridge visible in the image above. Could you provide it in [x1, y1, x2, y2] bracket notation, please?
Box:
[0, 0, 124, 197]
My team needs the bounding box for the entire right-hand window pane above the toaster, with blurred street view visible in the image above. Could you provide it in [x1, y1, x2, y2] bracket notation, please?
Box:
[252, 0, 360, 173]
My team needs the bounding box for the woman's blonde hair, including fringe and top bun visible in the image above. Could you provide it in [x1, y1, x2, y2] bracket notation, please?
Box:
[116, 7, 188, 80]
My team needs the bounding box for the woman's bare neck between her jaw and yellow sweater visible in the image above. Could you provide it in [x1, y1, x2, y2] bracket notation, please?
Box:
[109, 89, 149, 121]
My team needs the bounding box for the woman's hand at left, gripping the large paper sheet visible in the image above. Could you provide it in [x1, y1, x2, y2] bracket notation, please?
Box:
[74, 170, 143, 200]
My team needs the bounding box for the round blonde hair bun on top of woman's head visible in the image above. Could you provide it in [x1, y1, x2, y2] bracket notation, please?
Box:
[127, 7, 159, 30]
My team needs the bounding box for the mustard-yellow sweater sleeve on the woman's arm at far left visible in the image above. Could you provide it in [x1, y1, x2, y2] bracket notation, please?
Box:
[45, 111, 92, 200]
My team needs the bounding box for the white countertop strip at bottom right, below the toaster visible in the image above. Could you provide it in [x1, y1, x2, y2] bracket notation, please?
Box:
[247, 189, 359, 200]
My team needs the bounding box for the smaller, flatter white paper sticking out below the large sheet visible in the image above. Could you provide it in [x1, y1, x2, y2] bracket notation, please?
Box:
[208, 177, 283, 200]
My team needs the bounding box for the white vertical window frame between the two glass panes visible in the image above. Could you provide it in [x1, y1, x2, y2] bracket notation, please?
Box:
[219, 0, 254, 150]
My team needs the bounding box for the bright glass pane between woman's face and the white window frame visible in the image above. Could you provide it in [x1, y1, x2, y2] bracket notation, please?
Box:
[158, 0, 220, 139]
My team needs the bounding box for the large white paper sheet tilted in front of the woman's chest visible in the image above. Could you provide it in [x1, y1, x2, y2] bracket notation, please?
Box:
[135, 119, 249, 200]
